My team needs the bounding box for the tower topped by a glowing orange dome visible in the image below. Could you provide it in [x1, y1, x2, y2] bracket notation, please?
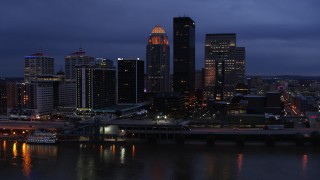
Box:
[146, 25, 170, 92]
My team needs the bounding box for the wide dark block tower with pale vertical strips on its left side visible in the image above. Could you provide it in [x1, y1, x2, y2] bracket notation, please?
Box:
[76, 65, 116, 109]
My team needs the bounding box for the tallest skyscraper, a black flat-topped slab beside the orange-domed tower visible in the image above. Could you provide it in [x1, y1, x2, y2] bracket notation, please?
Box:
[173, 17, 195, 102]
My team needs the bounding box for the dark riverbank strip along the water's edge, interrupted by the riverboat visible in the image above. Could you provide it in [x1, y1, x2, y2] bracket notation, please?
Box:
[0, 132, 320, 147]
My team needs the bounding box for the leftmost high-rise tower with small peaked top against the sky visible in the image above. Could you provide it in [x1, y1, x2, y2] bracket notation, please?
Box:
[24, 50, 54, 82]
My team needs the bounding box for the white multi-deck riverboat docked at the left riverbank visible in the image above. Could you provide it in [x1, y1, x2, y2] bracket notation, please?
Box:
[26, 131, 57, 144]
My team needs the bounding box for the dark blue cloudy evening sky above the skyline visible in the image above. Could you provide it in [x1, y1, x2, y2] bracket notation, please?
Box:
[0, 0, 320, 76]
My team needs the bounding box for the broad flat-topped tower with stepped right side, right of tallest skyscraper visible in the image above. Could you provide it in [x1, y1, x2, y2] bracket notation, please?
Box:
[204, 34, 245, 101]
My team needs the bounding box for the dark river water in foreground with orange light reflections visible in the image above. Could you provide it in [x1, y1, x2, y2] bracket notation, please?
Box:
[0, 141, 320, 180]
